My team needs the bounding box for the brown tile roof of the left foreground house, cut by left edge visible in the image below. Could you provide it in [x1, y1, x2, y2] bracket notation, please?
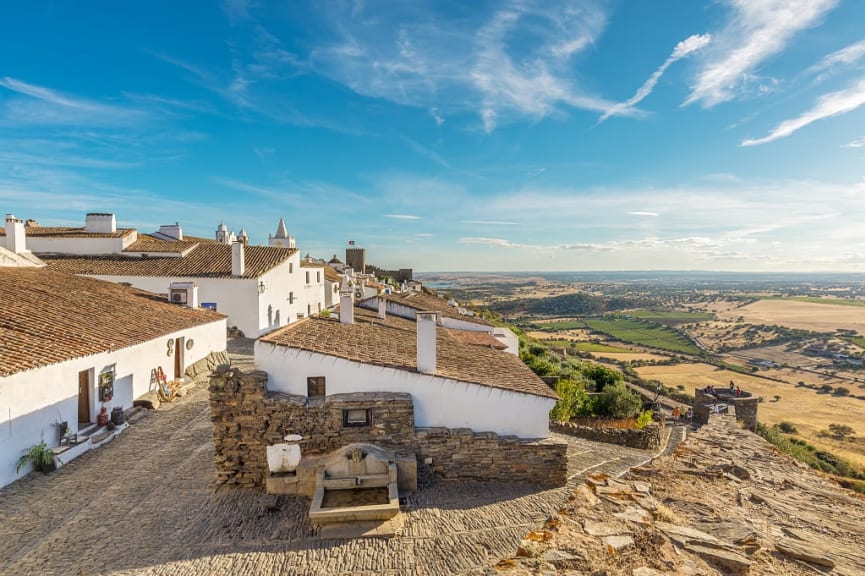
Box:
[0, 268, 225, 376]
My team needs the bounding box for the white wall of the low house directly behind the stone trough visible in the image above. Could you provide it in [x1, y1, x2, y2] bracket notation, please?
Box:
[255, 341, 555, 438]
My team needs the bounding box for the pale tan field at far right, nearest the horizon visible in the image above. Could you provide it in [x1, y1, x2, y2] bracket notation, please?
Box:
[717, 300, 865, 334]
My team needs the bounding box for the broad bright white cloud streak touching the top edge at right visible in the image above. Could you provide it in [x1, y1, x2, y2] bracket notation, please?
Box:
[684, 0, 838, 108]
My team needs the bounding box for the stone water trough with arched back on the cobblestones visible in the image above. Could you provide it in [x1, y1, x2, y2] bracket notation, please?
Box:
[309, 444, 399, 526]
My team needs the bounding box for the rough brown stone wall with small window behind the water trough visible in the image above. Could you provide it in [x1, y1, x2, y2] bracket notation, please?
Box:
[210, 369, 567, 486]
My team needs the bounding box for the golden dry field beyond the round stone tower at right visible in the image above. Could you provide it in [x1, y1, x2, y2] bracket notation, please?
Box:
[636, 363, 865, 469]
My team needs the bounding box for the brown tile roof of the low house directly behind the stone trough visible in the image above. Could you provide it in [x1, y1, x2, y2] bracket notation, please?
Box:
[261, 307, 558, 399]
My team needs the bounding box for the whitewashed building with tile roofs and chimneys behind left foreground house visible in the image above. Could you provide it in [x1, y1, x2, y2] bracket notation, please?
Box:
[0, 213, 325, 338]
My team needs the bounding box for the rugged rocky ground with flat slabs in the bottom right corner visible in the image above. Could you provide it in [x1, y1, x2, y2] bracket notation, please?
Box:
[491, 416, 865, 576]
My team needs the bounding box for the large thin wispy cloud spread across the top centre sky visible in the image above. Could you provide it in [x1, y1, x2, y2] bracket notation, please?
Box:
[310, 1, 627, 132]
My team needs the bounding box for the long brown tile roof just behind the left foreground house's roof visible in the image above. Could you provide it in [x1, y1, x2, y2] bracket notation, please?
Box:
[43, 243, 297, 278]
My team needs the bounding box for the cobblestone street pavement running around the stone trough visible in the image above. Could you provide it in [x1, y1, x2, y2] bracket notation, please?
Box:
[0, 344, 668, 576]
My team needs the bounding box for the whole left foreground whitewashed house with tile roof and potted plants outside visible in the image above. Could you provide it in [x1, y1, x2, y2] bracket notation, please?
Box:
[0, 266, 226, 486]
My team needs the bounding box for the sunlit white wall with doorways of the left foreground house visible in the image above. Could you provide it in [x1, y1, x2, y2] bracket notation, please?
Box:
[0, 319, 225, 486]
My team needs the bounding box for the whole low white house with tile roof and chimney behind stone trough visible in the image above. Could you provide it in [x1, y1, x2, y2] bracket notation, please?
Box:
[255, 304, 557, 438]
